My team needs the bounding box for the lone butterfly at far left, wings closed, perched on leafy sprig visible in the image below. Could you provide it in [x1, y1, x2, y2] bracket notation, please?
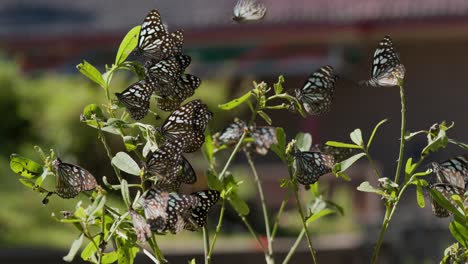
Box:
[52, 158, 97, 199]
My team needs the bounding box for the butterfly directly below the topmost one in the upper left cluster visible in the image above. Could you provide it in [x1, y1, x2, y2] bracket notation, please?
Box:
[145, 55, 192, 96]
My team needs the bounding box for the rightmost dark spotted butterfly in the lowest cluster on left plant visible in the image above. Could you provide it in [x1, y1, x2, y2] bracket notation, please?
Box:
[184, 190, 220, 231]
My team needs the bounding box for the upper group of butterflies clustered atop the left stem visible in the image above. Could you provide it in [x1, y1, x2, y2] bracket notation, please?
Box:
[116, 10, 201, 120]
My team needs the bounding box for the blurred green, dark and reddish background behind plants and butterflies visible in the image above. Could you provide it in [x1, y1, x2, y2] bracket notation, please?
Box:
[0, 0, 468, 263]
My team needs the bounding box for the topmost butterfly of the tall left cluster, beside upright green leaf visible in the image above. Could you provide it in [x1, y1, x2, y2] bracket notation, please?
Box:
[137, 10, 184, 61]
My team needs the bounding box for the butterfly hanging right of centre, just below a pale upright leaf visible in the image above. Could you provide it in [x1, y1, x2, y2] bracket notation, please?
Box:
[294, 151, 335, 186]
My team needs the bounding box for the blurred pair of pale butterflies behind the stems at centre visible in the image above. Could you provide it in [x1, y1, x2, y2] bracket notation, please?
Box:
[213, 119, 278, 155]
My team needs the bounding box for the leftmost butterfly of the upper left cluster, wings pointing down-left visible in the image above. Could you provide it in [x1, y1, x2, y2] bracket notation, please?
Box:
[115, 80, 154, 120]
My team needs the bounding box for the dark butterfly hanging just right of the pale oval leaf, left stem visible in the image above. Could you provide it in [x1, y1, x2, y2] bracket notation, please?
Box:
[145, 141, 183, 191]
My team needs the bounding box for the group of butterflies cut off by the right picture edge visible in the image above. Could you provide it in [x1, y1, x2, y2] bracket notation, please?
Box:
[429, 155, 468, 217]
